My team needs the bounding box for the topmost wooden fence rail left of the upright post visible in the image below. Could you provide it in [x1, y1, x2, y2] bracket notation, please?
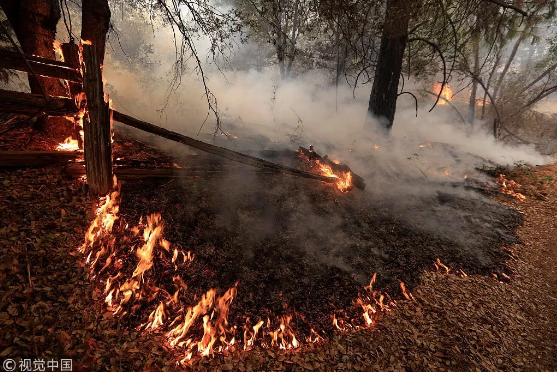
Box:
[0, 48, 82, 83]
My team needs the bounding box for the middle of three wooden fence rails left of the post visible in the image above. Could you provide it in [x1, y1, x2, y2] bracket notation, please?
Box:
[0, 89, 79, 116]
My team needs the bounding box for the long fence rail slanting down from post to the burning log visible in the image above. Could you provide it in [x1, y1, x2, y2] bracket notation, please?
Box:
[112, 110, 344, 183]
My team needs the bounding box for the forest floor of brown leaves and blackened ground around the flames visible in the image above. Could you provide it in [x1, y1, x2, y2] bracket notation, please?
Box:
[0, 127, 557, 371]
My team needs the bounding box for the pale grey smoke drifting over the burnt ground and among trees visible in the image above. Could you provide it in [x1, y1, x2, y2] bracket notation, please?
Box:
[95, 9, 551, 288]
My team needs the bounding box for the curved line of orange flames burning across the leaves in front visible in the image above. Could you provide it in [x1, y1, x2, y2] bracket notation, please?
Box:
[81, 177, 404, 363]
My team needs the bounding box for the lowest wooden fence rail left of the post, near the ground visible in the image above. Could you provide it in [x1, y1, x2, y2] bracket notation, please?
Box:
[0, 151, 83, 168]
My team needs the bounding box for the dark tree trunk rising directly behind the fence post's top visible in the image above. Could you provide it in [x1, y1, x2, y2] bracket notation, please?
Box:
[81, 0, 111, 66]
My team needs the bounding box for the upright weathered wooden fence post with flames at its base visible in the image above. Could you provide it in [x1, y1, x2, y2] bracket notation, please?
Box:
[82, 44, 112, 195]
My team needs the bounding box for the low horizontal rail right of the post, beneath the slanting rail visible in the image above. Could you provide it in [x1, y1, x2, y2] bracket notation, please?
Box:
[64, 163, 275, 180]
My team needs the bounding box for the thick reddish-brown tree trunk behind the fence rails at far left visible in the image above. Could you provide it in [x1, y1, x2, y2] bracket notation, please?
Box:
[0, 0, 74, 141]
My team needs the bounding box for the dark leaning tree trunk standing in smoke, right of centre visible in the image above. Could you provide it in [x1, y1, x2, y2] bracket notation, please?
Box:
[367, 0, 413, 134]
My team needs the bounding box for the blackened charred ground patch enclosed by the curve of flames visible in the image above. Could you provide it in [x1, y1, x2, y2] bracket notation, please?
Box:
[113, 146, 521, 334]
